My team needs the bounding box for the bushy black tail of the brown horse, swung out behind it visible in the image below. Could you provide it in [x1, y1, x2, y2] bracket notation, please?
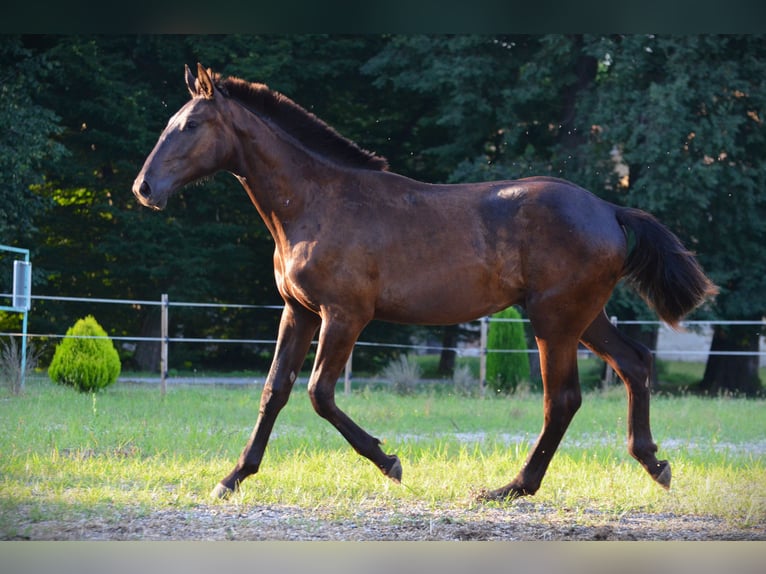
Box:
[615, 208, 718, 327]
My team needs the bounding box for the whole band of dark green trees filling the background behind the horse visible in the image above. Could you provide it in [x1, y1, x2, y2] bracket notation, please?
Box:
[0, 35, 766, 392]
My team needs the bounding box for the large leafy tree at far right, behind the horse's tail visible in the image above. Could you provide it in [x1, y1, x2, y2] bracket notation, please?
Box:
[580, 35, 766, 393]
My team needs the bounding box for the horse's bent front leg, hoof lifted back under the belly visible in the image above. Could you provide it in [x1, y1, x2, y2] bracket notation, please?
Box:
[308, 316, 402, 482]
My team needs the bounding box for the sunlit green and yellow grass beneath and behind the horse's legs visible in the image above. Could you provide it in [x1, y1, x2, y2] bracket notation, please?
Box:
[0, 379, 766, 539]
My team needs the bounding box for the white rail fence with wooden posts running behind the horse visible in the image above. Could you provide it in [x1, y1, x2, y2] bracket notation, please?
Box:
[0, 294, 766, 391]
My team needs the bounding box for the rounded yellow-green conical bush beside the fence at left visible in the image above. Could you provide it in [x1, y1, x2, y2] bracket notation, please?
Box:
[48, 315, 121, 392]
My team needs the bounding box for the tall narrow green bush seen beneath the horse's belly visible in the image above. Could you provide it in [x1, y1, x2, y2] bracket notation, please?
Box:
[487, 307, 530, 392]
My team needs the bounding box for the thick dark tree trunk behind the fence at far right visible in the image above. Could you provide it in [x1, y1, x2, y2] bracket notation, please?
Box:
[699, 325, 762, 396]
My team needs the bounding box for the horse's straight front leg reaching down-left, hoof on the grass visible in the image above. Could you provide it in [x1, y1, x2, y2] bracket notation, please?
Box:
[212, 303, 319, 498]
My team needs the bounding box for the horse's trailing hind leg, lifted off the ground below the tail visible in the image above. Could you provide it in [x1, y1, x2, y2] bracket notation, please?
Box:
[582, 313, 670, 488]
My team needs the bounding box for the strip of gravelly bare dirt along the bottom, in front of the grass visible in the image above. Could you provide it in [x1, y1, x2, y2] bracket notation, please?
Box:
[11, 501, 766, 541]
